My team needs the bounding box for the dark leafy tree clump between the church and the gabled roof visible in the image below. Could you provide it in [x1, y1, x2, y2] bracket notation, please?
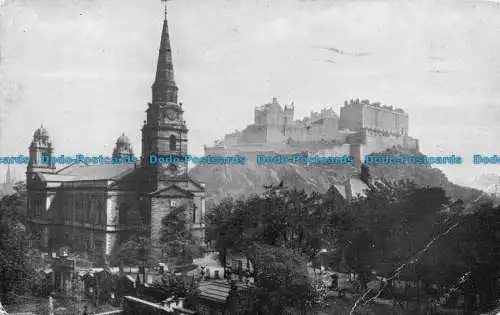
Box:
[207, 185, 331, 265]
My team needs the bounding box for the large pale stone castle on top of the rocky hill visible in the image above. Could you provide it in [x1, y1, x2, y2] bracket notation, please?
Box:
[205, 98, 419, 162]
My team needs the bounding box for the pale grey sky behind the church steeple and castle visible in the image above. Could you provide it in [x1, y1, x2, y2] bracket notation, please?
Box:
[0, 0, 500, 182]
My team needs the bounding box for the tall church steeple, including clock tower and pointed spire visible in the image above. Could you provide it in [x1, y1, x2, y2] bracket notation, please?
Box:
[142, 6, 188, 190]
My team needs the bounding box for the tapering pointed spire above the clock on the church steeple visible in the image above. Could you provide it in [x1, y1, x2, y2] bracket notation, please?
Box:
[153, 4, 178, 104]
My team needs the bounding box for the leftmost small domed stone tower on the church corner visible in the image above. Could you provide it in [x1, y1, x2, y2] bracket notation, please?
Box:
[26, 126, 56, 179]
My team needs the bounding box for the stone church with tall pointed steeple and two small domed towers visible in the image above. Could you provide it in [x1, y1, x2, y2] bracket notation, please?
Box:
[26, 11, 205, 264]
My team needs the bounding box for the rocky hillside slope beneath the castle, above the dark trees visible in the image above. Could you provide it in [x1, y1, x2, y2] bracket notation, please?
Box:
[190, 149, 482, 204]
